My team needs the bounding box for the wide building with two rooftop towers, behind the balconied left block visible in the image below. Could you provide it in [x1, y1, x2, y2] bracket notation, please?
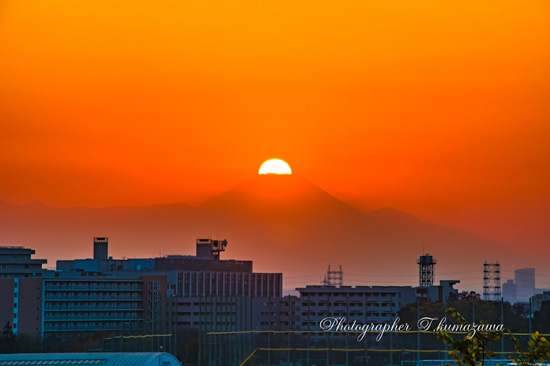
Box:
[57, 237, 283, 331]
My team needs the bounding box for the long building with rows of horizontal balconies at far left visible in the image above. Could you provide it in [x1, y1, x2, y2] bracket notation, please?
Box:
[0, 276, 171, 339]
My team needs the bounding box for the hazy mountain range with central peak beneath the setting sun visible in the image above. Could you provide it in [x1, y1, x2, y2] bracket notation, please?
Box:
[0, 175, 548, 288]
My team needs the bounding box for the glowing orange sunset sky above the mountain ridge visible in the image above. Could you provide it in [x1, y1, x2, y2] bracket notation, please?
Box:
[0, 0, 550, 243]
